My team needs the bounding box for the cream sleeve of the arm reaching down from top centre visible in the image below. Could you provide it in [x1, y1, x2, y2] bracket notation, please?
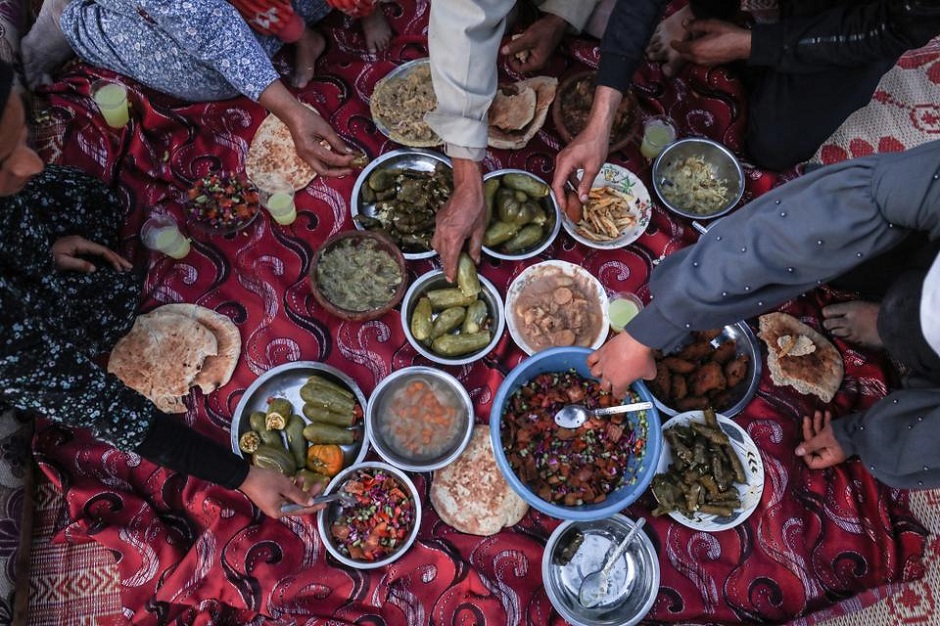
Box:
[425, 0, 514, 161]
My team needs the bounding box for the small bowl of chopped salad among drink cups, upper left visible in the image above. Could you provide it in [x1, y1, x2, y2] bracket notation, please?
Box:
[185, 172, 261, 235]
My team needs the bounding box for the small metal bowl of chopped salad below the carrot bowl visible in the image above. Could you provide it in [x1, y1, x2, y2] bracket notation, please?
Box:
[317, 462, 421, 569]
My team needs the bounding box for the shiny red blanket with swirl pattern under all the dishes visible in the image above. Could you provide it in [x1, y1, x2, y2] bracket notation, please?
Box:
[29, 0, 925, 626]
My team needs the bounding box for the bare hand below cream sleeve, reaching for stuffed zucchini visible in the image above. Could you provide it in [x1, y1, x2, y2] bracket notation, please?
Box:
[431, 159, 486, 282]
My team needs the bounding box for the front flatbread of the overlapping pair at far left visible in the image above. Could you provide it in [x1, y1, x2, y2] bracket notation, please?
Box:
[108, 313, 219, 413]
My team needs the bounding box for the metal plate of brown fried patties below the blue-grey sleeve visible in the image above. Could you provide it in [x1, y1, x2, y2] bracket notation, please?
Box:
[647, 322, 761, 416]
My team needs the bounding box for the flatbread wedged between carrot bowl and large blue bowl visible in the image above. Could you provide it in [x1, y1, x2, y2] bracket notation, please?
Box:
[431, 424, 529, 536]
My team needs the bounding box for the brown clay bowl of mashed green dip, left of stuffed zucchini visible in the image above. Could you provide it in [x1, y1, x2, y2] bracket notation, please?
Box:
[310, 231, 408, 321]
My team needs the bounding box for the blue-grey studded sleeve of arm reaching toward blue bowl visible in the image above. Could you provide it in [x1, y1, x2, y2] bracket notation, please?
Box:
[627, 141, 940, 349]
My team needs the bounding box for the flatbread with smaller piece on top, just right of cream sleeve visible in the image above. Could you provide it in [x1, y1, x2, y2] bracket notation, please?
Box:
[487, 76, 558, 150]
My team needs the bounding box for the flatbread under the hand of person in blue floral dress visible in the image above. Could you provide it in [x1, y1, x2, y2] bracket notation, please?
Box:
[245, 103, 317, 191]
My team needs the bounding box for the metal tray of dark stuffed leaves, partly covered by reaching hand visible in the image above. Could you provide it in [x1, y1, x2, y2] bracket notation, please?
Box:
[350, 148, 454, 260]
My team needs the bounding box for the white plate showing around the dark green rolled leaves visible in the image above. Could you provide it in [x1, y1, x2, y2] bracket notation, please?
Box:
[656, 411, 764, 532]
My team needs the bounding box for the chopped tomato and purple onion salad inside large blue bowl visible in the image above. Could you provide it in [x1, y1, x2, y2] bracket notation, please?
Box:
[500, 372, 646, 506]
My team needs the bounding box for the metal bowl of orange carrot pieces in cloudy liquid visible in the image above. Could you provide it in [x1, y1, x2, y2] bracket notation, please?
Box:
[366, 366, 474, 472]
